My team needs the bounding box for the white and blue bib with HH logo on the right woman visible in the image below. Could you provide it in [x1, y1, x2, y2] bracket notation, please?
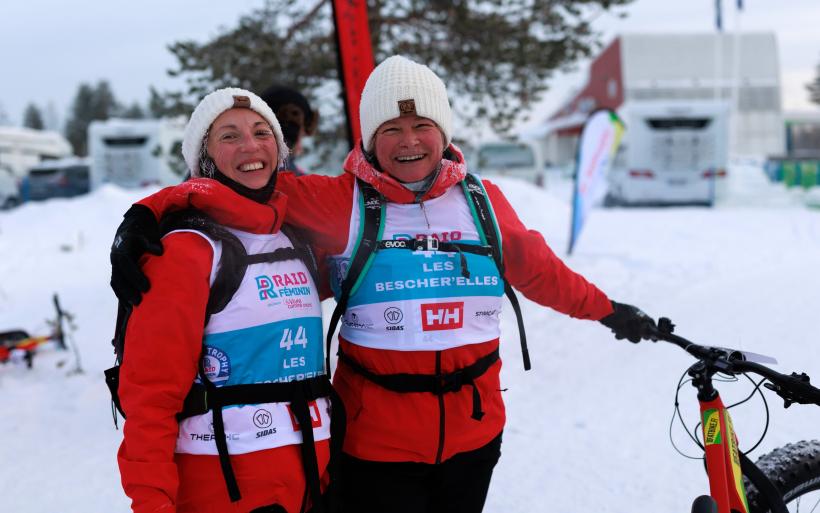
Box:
[331, 183, 504, 351]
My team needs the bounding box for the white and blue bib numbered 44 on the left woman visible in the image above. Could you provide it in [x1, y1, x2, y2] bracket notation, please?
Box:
[176, 229, 330, 455]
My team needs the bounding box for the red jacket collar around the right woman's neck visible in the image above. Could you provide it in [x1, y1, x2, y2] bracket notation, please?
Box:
[344, 143, 467, 203]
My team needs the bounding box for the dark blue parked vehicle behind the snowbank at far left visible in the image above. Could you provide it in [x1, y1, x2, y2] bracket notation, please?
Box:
[22, 158, 91, 201]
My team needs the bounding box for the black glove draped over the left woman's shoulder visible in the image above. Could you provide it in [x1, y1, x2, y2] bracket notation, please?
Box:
[111, 205, 162, 305]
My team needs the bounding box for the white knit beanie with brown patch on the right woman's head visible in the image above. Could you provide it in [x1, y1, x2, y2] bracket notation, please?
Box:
[359, 55, 453, 152]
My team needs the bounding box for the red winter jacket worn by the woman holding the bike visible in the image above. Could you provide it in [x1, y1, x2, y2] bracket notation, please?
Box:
[141, 146, 612, 463]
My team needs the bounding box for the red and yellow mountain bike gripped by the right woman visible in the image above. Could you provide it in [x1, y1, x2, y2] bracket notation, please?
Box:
[649, 317, 820, 513]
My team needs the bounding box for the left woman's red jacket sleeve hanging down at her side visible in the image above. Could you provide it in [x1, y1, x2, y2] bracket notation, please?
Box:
[117, 232, 213, 513]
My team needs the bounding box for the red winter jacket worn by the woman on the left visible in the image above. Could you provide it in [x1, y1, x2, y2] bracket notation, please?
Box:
[118, 184, 329, 513]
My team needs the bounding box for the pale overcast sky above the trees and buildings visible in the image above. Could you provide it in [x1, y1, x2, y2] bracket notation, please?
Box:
[0, 0, 820, 131]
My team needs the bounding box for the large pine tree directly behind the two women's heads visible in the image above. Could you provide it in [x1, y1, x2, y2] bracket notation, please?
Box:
[159, 0, 632, 144]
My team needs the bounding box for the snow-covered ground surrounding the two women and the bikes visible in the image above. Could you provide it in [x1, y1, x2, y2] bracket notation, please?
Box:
[0, 166, 820, 513]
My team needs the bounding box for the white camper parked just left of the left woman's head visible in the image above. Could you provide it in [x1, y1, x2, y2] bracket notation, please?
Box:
[88, 118, 186, 188]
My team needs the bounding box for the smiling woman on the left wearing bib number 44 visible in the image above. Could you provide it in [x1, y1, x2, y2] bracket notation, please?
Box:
[118, 88, 330, 513]
